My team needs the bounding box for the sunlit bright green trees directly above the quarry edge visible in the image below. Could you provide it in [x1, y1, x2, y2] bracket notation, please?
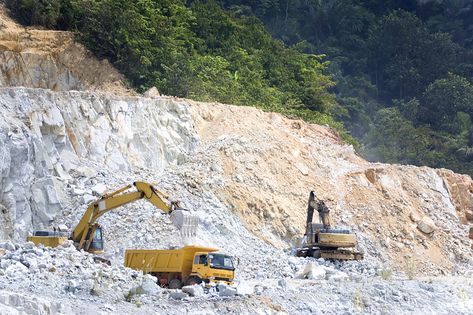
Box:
[6, 0, 343, 130]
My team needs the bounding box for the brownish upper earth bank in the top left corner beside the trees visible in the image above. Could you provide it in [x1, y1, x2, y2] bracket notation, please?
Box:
[0, 4, 132, 95]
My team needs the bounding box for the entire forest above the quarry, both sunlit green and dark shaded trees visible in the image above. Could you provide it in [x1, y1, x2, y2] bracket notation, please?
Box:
[5, 0, 473, 174]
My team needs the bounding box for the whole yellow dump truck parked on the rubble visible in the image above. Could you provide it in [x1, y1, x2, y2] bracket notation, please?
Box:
[125, 246, 235, 289]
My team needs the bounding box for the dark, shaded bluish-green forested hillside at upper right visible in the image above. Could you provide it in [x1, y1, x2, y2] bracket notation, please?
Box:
[213, 0, 473, 174]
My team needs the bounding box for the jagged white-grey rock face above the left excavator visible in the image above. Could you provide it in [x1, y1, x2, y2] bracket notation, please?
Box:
[0, 88, 197, 240]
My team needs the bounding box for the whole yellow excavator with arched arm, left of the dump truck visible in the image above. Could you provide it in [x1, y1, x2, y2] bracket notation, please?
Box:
[28, 182, 198, 254]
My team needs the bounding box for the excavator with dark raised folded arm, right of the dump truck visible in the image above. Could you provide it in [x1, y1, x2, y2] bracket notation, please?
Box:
[296, 191, 363, 260]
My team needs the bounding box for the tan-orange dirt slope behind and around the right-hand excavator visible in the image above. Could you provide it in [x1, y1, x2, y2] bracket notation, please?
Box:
[192, 103, 473, 273]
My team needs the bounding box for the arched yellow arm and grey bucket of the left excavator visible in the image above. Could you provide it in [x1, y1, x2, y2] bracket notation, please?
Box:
[71, 182, 198, 252]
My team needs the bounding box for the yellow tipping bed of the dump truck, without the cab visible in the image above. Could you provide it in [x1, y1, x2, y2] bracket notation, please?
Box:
[125, 246, 218, 274]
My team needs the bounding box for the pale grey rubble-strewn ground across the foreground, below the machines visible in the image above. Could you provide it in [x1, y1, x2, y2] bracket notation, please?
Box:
[0, 242, 473, 314]
